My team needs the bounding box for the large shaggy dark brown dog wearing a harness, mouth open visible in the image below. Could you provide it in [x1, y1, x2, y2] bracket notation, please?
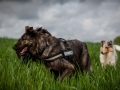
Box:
[13, 26, 92, 81]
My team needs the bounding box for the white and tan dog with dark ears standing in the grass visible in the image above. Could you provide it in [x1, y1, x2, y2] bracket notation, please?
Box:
[100, 41, 120, 67]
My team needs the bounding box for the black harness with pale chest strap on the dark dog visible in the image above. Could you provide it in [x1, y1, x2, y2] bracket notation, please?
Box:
[44, 38, 74, 62]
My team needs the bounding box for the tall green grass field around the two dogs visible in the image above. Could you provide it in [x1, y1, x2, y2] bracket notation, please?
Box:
[0, 38, 120, 90]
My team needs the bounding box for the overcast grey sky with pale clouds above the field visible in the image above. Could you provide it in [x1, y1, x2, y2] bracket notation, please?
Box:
[0, 0, 120, 42]
